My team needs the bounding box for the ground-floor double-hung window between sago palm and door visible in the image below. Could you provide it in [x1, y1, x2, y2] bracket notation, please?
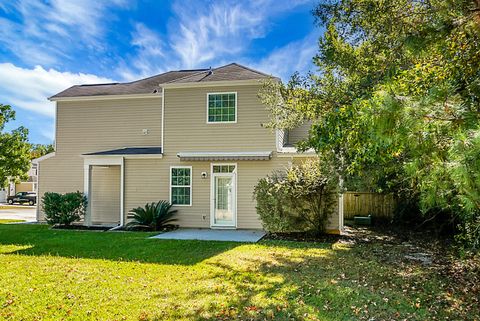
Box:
[170, 166, 192, 206]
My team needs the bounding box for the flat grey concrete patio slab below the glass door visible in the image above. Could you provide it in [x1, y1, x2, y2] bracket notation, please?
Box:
[151, 228, 265, 243]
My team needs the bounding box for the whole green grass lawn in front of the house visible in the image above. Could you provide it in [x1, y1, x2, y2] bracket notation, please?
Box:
[0, 224, 479, 320]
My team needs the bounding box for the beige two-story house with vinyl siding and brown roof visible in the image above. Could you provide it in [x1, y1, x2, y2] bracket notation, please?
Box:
[37, 64, 343, 232]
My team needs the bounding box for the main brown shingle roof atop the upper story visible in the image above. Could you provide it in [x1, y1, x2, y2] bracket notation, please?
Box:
[50, 63, 271, 99]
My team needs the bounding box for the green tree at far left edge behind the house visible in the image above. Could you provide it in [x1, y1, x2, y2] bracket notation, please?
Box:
[0, 104, 30, 186]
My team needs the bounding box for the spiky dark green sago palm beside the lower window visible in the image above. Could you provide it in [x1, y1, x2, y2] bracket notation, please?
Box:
[126, 201, 177, 231]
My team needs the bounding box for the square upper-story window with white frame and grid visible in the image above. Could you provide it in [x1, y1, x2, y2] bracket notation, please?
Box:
[207, 93, 237, 123]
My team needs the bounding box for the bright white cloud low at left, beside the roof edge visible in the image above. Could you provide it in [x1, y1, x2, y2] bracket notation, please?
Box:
[0, 63, 112, 118]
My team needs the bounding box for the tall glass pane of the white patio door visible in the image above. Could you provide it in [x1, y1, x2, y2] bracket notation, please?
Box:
[215, 177, 233, 224]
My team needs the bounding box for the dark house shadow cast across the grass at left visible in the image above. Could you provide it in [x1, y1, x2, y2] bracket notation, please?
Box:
[0, 224, 239, 265]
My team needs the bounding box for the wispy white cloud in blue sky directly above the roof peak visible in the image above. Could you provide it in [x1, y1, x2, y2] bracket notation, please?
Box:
[122, 0, 315, 80]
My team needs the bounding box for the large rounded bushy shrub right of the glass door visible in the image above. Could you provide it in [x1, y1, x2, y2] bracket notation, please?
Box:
[254, 160, 338, 234]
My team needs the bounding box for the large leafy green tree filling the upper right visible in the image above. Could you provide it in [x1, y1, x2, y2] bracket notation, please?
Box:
[260, 0, 480, 246]
